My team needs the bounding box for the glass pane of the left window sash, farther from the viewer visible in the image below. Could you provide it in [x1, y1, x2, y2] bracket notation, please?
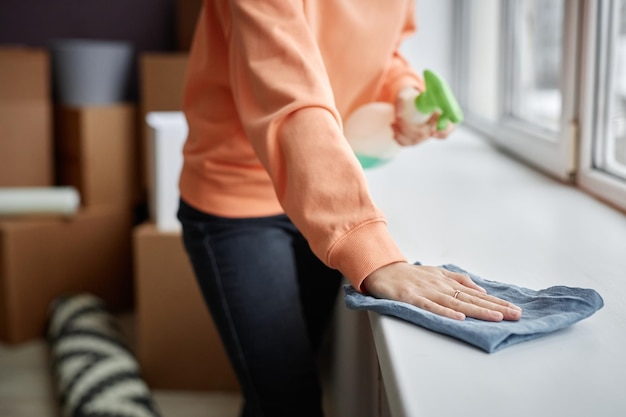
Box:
[510, 0, 565, 131]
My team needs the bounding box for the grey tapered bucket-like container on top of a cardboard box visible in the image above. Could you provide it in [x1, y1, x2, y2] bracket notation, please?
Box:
[51, 39, 133, 106]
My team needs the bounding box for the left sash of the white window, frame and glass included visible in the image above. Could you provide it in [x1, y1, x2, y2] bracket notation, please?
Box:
[456, 0, 579, 181]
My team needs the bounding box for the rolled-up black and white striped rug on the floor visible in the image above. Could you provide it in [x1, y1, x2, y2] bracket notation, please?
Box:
[47, 294, 160, 417]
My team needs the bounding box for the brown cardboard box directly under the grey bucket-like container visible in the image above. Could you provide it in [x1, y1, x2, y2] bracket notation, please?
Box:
[55, 104, 140, 207]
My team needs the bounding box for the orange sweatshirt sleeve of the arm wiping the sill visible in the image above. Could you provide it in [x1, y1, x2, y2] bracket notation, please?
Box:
[224, 0, 405, 289]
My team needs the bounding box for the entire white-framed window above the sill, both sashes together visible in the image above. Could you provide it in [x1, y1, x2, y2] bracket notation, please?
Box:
[455, 0, 626, 210]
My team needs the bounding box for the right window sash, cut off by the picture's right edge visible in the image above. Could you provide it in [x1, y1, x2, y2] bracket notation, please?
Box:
[579, 0, 626, 209]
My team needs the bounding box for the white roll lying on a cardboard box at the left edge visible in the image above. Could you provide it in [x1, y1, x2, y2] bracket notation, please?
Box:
[0, 187, 80, 216]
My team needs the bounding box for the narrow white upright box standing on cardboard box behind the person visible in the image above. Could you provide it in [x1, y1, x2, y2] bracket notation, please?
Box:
[146, 112, 188, 231]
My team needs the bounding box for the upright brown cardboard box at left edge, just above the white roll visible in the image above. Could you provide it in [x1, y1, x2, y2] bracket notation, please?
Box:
[0, 47, 54, 187]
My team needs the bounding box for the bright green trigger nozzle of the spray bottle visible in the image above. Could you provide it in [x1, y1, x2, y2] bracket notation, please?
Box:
[415, 70, 463, 130]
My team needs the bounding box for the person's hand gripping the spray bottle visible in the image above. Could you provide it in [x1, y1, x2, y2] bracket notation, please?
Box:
[391, 87, 454, 146]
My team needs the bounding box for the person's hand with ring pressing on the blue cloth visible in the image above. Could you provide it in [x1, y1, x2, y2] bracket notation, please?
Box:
[362, 262, 522, 321]
